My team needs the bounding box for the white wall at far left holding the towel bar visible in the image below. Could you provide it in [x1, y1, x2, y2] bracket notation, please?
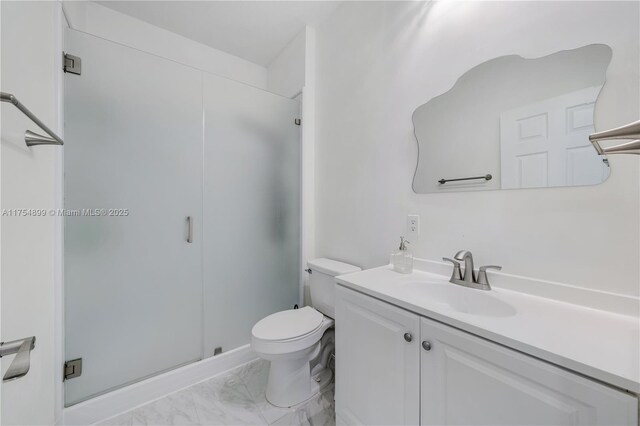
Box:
[0, 2, 62, 425]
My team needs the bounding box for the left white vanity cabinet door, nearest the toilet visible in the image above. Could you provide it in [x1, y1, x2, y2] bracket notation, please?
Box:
[335, 286, 420, 425]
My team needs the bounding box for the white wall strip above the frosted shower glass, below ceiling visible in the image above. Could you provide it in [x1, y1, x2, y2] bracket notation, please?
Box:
[64, 1, 267, 89]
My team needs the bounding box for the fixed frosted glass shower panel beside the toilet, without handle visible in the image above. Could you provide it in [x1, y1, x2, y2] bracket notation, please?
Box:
[203, 74, 300, 357]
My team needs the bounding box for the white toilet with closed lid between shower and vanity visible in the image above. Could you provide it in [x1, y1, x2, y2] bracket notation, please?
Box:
[251, 258, 360, 407]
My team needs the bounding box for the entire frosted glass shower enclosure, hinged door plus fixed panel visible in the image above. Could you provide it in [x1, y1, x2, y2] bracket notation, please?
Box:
[64, 30, 300, 406]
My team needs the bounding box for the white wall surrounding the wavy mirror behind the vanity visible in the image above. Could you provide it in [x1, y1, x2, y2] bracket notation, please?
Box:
[316, 1, 640, 296]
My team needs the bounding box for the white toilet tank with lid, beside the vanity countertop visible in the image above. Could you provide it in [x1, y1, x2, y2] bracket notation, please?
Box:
[307, 258, 362, 318]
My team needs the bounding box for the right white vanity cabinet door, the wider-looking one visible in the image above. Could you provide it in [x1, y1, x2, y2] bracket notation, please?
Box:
[420, 318, 638, 425]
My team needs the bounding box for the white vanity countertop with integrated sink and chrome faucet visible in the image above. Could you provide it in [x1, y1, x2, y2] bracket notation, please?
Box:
[337, 266, 640, 393]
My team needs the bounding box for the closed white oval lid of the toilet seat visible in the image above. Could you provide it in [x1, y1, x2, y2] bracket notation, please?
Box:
[251, 306, 324, 340]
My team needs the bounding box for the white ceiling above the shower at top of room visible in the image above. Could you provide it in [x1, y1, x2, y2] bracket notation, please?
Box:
[98, 0, 340, 66]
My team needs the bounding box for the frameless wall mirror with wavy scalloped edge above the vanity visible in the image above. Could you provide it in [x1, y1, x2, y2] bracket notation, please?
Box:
[413, 44, 612, 194]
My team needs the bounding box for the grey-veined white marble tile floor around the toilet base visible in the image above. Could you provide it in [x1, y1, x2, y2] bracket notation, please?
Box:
[99, 359, 335, 426]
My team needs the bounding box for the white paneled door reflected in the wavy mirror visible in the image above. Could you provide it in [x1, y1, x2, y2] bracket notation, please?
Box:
[500, 86, 609, 189]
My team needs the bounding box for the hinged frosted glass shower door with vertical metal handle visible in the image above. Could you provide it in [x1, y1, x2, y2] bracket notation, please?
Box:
[64, 30, 202, 405]
